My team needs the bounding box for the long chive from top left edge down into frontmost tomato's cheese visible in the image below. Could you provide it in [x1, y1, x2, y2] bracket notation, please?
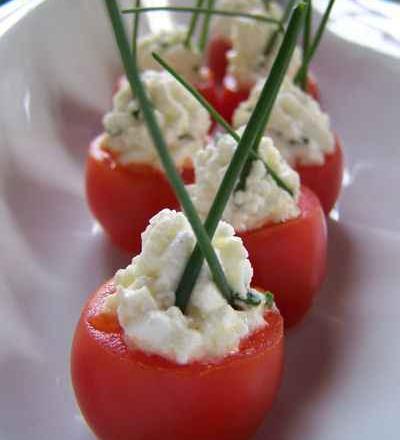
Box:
[104, 0, 233, 301]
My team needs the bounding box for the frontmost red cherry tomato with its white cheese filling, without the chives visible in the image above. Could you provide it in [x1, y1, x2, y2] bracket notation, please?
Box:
[71, 210, 283, 440]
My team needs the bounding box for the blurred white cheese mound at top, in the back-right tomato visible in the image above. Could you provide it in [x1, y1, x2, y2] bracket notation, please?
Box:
[213, 0, 301, 86]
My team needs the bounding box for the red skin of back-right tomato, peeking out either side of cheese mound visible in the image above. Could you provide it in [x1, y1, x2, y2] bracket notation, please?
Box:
[220, 75, 320, 122]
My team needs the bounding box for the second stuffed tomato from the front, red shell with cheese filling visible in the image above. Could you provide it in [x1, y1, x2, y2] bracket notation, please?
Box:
[188, 129, 327, 326]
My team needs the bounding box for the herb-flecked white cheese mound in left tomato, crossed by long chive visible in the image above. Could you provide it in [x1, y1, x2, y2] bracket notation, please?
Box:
[103, 70, 211, 166]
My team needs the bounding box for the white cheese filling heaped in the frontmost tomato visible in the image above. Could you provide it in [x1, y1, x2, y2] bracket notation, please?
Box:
[104, 209, 267, 364]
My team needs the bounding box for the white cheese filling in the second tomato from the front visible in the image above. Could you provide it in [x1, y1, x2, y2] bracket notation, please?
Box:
[188, 130, 300, 232]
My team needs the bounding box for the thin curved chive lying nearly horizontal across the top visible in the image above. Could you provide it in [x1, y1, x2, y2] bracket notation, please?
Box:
[122, 6, 283, 32]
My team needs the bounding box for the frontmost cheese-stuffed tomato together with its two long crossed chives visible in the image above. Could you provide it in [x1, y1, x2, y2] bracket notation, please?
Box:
[71, 0, 306, 440]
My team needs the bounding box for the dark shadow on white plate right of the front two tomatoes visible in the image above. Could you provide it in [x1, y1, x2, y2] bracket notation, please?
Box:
[254, 220, 354, 440]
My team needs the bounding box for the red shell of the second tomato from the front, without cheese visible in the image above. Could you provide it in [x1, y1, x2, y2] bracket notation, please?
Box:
[238, 187, 327, 327]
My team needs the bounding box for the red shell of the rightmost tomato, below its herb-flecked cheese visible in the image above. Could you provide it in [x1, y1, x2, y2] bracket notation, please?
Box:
[295, 137, 343, 214]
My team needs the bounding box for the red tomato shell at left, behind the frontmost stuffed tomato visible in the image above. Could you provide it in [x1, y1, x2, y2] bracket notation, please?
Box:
[86, 138, 194, 254]
